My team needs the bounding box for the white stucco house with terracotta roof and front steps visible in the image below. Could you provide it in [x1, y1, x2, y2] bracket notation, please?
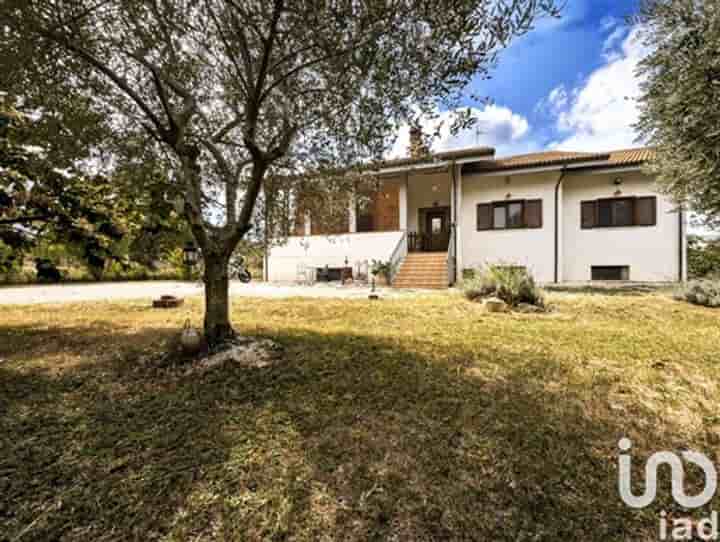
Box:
[266, 147, 686, 288]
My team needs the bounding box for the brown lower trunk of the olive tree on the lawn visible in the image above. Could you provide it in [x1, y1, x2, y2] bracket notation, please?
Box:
[204, 253, 235, 346]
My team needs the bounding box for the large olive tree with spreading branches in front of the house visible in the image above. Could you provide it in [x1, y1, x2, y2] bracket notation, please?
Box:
[0, 0, 557, 343]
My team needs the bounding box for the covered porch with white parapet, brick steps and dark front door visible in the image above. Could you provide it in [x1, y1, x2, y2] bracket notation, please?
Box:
[268, 168, 455, 288]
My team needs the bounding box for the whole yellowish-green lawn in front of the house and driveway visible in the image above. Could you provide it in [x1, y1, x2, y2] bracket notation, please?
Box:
[0, 293, 720, 541]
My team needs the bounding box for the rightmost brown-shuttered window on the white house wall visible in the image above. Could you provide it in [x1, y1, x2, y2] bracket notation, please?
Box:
[580, 196, 657, 229]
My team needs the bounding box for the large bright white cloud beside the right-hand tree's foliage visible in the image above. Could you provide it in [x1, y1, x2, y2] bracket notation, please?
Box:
[541, 28, 647, 151]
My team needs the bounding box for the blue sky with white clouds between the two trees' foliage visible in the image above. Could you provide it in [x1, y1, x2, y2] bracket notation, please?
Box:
[393, 0, 645, 156]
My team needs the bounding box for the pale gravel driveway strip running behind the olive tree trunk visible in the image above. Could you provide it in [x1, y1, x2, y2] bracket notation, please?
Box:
[0, 281, 428, 305]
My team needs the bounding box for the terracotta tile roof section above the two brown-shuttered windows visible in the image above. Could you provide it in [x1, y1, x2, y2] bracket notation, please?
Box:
[471, 148, 654, 173]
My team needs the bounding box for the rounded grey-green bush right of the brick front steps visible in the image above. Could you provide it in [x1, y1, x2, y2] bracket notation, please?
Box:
[462, 265, 545, 308]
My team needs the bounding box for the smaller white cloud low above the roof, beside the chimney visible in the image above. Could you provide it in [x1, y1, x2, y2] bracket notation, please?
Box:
[390, 105, 539, 157]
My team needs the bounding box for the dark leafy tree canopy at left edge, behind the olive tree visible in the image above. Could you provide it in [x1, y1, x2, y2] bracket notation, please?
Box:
[0, 97, 182, 276]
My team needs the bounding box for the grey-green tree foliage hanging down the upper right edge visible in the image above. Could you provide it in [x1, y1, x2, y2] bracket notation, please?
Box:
[638, 0, 720, 225]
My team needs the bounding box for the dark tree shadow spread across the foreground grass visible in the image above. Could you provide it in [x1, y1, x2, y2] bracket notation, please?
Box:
[0, 328, 700, 541]
